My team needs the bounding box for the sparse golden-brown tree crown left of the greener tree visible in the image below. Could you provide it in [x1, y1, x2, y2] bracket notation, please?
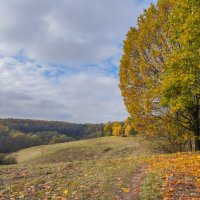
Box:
[120, 0, 173, 134]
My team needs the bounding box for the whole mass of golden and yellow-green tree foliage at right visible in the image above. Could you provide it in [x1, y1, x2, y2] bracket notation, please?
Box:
[120, 0, 200, 150]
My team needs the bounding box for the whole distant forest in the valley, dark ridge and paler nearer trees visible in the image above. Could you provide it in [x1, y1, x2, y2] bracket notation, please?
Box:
[0, 119, 104, 153]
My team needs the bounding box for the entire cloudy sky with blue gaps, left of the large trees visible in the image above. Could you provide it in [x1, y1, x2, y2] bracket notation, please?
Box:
[0, 0, 155, 123]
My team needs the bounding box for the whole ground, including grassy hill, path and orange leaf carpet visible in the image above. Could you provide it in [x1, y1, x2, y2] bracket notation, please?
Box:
[0, 135, 200, 200]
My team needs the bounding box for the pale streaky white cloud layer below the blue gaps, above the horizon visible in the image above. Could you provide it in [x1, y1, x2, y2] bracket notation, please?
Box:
[0, 55, 126, 122]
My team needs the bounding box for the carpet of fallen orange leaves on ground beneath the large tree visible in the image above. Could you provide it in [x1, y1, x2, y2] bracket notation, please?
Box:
[148, 153, 200, 200]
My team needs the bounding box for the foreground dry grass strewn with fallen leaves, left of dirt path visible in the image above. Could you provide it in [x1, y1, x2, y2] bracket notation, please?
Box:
[0, 158, 146, 200]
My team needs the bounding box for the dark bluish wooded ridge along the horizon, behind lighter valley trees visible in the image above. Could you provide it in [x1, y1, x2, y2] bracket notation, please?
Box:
[0, 118, 104, 140]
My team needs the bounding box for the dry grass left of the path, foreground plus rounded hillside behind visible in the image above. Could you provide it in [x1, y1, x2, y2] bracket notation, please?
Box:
[0, 136, 155, 200]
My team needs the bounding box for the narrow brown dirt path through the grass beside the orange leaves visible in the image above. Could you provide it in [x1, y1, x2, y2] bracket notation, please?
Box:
[119, 165, 147, 200]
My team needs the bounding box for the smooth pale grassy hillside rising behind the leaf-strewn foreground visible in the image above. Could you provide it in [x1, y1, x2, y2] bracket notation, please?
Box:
[13, 135, 153, 164]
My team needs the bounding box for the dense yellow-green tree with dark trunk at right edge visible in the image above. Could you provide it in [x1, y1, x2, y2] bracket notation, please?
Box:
[159, 0, 200, 150]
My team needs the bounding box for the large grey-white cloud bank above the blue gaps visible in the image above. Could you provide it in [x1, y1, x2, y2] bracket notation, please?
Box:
[0, 0, 155, 65]
